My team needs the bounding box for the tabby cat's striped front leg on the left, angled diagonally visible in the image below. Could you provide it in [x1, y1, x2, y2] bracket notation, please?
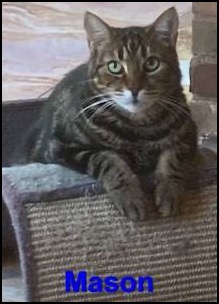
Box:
[87, 151, 146, 220]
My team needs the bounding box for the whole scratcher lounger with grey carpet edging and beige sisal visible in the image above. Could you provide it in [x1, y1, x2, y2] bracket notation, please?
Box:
[3, 152, 217, 302]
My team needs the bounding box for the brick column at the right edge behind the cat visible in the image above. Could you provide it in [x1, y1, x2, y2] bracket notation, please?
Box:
[190, 2, 217, 136]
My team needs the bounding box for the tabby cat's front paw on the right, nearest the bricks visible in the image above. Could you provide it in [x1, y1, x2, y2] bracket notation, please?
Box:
[155, 183, 183, 217]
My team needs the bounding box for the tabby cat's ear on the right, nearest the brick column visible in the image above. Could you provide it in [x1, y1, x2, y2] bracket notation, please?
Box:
[153, 7, 179, 46]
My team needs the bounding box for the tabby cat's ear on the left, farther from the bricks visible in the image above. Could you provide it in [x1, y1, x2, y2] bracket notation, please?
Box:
[84, 12, 110, 48]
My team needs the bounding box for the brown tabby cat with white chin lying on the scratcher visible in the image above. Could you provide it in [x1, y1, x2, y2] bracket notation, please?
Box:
[18, 8, 197, 220]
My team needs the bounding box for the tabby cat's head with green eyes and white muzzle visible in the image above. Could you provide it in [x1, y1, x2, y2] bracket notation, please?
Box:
[84, 8, 181, 117]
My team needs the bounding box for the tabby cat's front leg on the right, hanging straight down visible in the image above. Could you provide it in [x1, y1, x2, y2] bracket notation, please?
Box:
[155, 150, 186, 216]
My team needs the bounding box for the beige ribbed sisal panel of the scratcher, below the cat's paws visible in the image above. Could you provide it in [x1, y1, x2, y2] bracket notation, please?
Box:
[25, 185, 217, 302]
